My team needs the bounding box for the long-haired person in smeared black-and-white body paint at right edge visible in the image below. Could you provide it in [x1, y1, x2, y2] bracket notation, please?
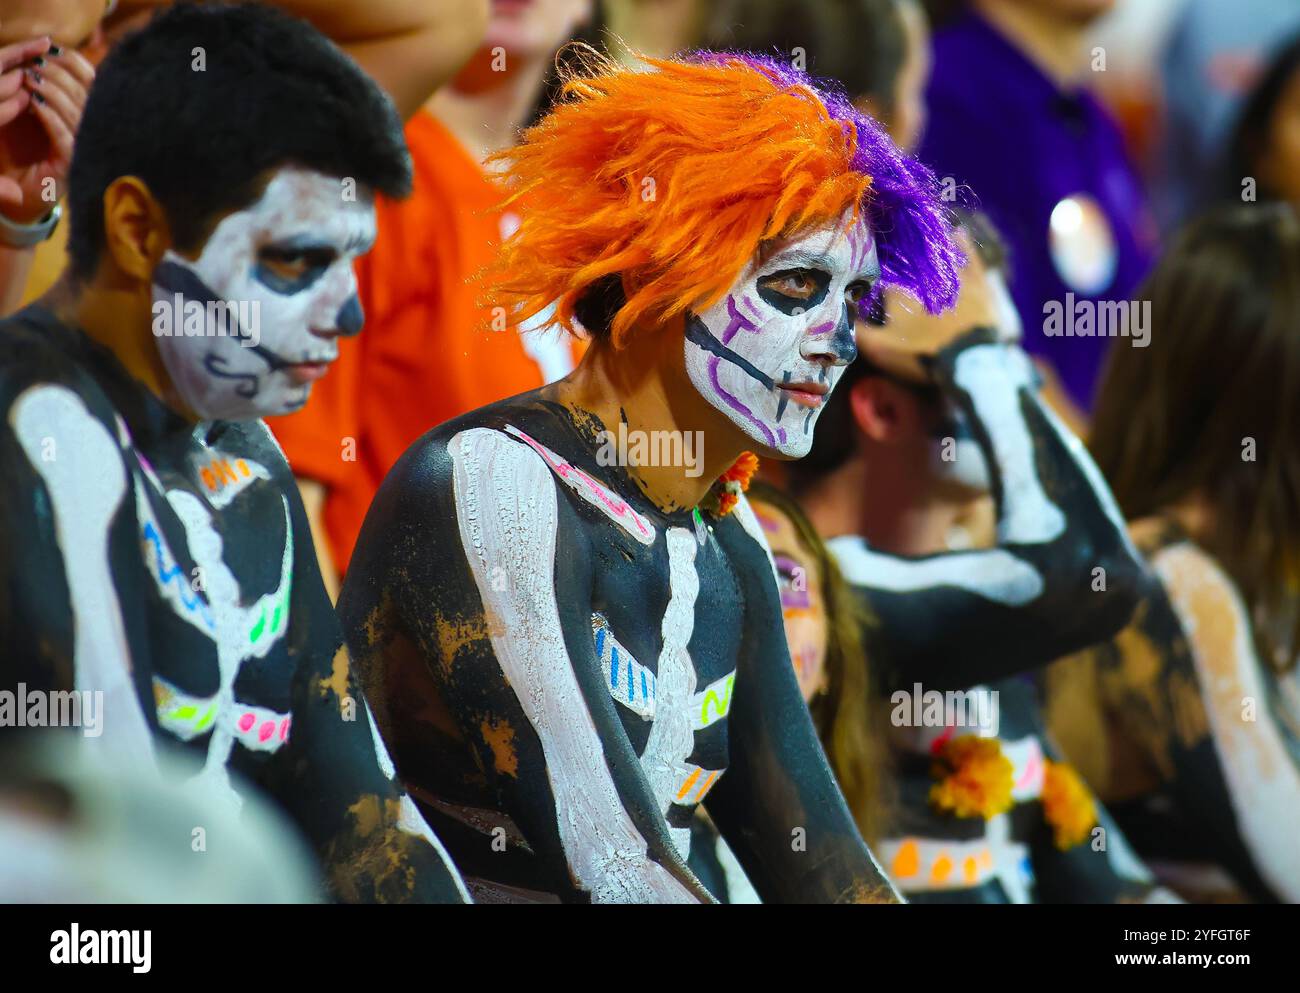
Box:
[1047, 201, 1300, 903]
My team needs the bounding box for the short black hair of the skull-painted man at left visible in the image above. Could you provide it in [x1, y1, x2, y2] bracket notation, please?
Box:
[68, 3, 411, 278]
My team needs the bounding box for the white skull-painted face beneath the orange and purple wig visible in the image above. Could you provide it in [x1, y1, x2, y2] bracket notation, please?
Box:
[686, 214, 880, 459]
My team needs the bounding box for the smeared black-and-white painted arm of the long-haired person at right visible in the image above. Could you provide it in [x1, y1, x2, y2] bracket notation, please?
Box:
[1047, 535, 1300, 902]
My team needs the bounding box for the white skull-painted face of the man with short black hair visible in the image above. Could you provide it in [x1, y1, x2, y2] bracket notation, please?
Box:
[153, 168, 374, 420]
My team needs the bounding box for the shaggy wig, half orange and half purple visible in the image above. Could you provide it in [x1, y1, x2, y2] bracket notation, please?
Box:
[488, 52, 961, 346]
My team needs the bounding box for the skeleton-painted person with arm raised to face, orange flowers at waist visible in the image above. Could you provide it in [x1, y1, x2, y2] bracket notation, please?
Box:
[780, 217, 1167, 902]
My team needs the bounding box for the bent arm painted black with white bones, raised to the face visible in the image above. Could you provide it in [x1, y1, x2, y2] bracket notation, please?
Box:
[828, 329, 1144, 689]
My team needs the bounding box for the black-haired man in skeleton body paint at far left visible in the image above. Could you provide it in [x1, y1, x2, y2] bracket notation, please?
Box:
[0, 5, 468, 902]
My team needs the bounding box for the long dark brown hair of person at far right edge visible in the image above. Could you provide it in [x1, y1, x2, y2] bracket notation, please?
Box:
[1091, 203, 1300, 668]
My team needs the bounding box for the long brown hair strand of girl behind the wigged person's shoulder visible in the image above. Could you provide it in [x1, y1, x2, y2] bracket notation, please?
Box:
[749, 480, 892, 842]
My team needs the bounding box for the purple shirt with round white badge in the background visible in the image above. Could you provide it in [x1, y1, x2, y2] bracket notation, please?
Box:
[919, 14, 1154, 409]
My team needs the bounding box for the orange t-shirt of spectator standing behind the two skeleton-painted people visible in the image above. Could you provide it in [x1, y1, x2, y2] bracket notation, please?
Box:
[268, 110, 572, 573]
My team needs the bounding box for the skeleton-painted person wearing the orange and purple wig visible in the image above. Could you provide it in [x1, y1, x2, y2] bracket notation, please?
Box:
[339, 53, 956, 902]
